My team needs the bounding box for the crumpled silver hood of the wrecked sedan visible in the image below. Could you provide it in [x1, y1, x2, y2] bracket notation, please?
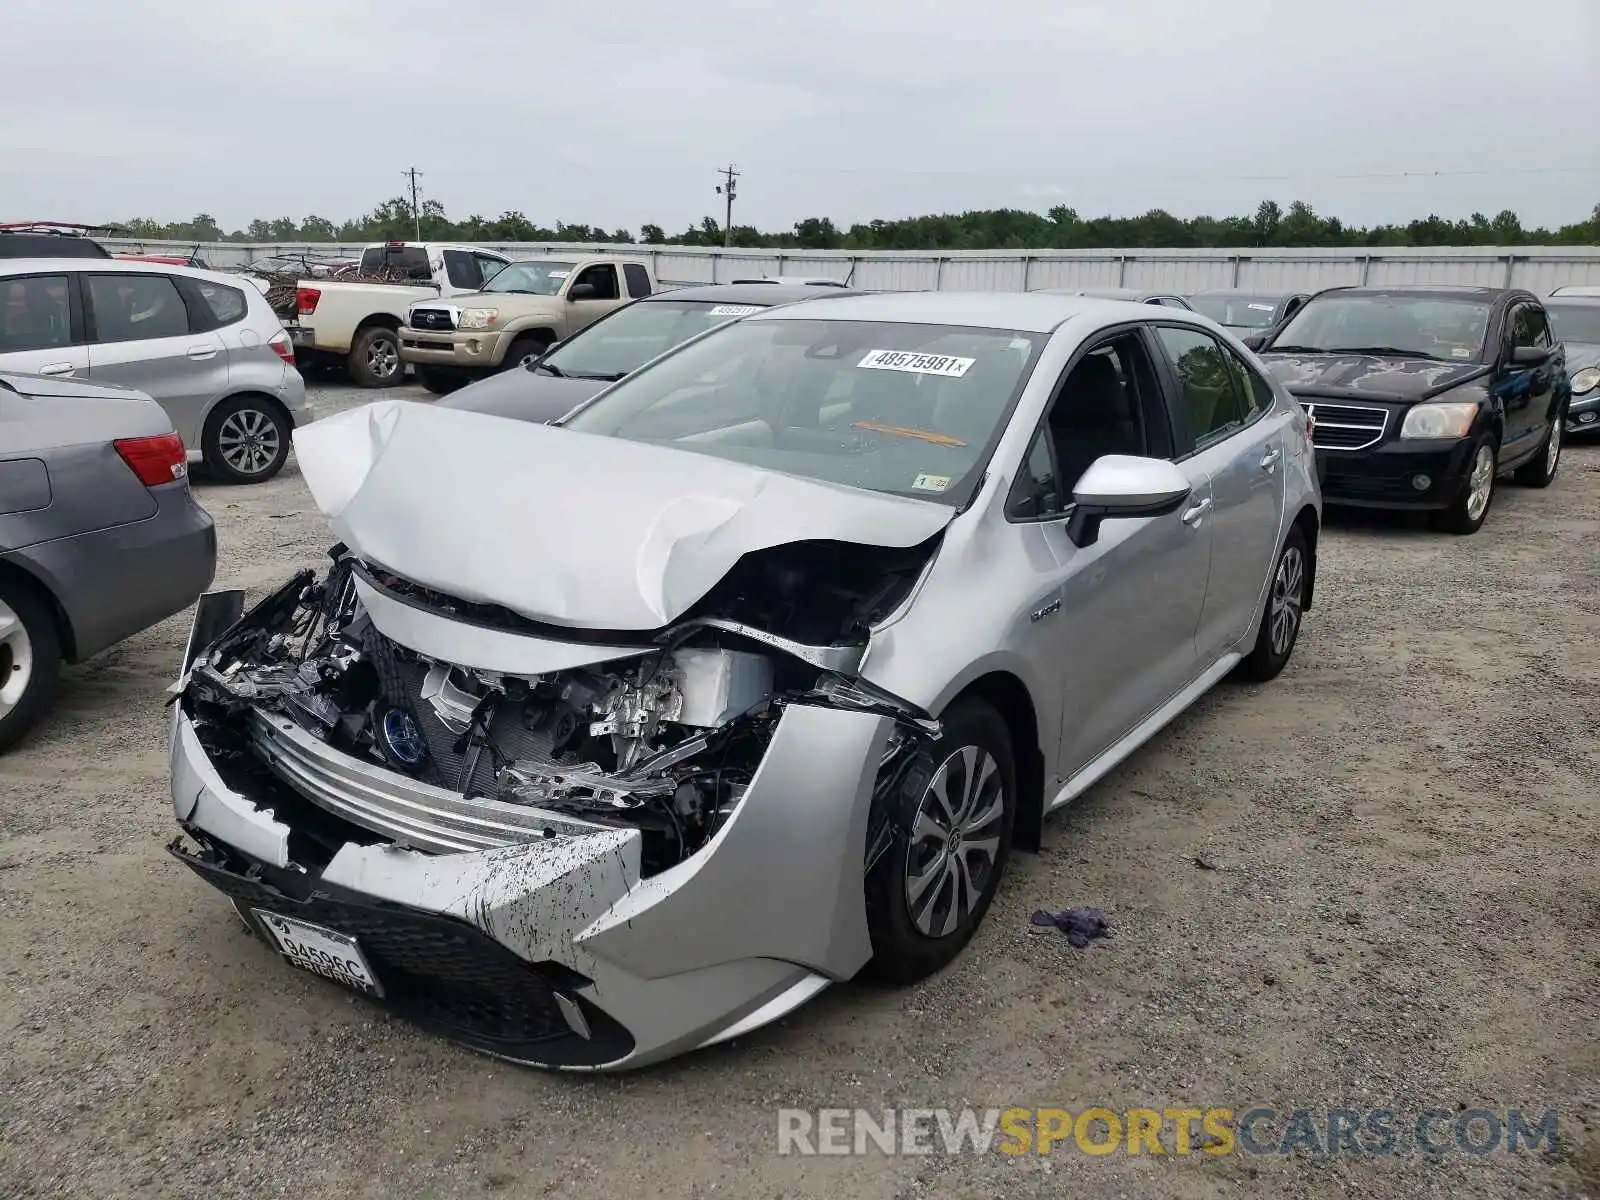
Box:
[294, 400, 955, 630]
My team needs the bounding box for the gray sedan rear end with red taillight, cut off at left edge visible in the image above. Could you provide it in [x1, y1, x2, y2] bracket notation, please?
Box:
[0, 373, 216, 750]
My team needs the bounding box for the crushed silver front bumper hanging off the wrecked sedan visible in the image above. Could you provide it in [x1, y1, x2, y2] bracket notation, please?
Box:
[171, 597, 891, 1069]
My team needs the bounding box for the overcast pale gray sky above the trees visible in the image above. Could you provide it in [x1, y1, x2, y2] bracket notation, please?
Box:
[0, 0, 1600, 232]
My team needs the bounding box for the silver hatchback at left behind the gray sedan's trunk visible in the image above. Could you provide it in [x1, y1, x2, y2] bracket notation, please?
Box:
[0, 259, 310, 483]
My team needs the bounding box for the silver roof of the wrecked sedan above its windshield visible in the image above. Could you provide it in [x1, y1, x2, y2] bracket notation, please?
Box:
[746, 291, 1182, 333]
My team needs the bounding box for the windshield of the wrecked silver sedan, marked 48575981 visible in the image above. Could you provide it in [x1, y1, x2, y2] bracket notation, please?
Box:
[563, 320, 1046, 507]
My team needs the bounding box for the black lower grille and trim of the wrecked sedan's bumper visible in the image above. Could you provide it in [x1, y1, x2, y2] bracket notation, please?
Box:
[168, 843, 634, 1066]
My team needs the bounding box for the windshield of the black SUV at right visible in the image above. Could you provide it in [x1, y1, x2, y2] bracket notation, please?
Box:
[1267, 293, 1490, 362]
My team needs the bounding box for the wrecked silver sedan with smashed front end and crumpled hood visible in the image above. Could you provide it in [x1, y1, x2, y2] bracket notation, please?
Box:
[171, 293, 1320, 1069]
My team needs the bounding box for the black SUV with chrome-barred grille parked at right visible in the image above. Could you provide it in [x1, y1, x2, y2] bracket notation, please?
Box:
[1251, 283, 1571, 533]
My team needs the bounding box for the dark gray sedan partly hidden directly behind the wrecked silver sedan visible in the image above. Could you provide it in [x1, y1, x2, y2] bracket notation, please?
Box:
[438, 283, 858, 424]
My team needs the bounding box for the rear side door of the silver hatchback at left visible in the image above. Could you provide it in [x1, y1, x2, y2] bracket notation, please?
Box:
[83, 274, 227, 448]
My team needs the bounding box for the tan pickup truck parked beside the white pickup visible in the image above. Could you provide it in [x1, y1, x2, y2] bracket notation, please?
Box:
[400, 256, 656, 394]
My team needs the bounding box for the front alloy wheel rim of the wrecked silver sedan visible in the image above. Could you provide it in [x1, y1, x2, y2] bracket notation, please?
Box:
[906, 746, 1005, 938]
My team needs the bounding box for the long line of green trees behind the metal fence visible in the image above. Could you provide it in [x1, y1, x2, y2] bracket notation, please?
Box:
[117, 197, 1600, 250]
